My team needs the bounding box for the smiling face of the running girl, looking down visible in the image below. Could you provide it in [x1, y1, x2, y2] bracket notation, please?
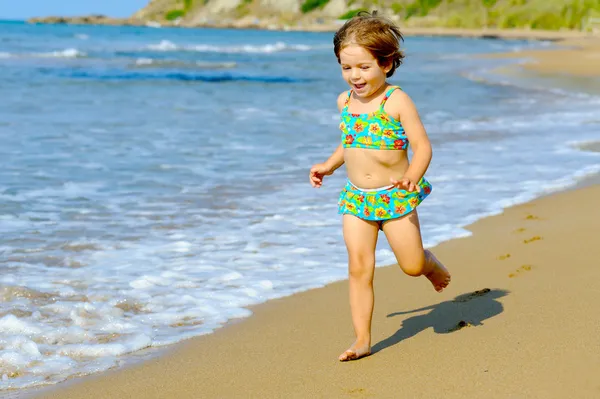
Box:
[340, 44, 391, 98]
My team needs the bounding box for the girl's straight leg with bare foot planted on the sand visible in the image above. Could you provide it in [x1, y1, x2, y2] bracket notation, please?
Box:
[339, 215, 379, 361]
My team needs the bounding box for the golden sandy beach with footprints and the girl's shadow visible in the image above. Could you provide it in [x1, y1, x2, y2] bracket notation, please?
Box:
[31, 33, 600, 399]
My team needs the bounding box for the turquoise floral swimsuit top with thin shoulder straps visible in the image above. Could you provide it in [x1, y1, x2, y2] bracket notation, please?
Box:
[340, 86, 408, 150]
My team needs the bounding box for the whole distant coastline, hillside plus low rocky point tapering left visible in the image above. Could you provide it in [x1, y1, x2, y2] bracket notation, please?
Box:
[28, 0, 600, 40]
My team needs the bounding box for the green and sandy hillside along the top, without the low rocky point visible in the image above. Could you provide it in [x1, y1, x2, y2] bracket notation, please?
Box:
[44, 0, 600, 31]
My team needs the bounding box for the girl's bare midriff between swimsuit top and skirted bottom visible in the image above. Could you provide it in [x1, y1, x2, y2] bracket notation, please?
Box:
[344, 148, 408, 188]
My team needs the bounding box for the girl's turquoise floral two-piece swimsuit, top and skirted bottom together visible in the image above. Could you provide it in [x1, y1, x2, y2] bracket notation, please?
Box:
[338, 86, 432, 228]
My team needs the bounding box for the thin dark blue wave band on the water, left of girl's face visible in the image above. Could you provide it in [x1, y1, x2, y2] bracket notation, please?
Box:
[59, 70, 310, 83]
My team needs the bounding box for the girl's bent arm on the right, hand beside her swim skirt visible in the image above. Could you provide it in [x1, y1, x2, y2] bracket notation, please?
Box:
[388, 90, 432, 191]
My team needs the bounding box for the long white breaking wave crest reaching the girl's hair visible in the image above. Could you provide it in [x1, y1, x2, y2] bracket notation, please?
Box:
[145, 40, 329, 54]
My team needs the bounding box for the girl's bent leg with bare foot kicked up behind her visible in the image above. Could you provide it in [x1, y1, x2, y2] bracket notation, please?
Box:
[383, 210, 450, 292]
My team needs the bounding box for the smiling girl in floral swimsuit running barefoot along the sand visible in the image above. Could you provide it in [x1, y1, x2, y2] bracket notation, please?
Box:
[310, 12, 450, 361]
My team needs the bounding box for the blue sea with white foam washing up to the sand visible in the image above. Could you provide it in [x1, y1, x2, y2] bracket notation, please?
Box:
[0, 21, 600, 393]
